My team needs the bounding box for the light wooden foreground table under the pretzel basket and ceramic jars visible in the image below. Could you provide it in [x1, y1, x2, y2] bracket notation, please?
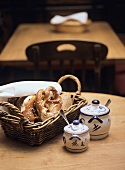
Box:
[0, 93, 125, 170]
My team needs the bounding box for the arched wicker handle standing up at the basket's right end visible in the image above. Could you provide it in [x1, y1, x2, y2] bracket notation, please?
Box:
[58, 74, 81, 94]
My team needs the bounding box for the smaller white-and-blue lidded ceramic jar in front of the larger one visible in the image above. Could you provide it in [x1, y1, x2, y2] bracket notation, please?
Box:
[63, 120, 90, 152]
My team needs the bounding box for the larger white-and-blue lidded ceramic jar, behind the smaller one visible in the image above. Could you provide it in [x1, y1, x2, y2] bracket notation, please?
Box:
[79, 100, 111, 140]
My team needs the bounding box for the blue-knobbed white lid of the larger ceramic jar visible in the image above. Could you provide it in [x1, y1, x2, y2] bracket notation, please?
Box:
[80, 100, 110, 116]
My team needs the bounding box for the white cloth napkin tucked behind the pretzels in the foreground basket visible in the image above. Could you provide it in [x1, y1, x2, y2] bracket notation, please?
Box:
[0, 81, 62, 98]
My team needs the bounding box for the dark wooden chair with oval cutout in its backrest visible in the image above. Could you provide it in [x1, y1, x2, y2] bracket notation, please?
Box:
[26, 40, 108, 90]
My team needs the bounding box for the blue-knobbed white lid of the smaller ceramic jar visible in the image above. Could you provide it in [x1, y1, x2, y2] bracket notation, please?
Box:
[64, 120, 89, 135]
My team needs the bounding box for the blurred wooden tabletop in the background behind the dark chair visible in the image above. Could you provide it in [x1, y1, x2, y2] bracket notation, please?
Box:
[0, 22, 125, 63]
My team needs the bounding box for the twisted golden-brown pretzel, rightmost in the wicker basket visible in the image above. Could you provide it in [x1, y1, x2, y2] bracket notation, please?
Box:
[35, 86, 62, 121]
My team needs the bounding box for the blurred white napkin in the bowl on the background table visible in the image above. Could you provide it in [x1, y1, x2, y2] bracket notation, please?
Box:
[50, 12, 88, 24]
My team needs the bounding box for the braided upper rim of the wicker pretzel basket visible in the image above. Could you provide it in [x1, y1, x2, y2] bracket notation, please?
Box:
[0, 95, 87, 129]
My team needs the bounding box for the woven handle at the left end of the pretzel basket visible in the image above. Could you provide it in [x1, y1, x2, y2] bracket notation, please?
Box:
[0, 102, 24, 118]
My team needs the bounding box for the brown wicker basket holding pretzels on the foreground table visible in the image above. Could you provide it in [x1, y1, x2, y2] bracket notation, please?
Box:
[0, 75, 87, 145]
